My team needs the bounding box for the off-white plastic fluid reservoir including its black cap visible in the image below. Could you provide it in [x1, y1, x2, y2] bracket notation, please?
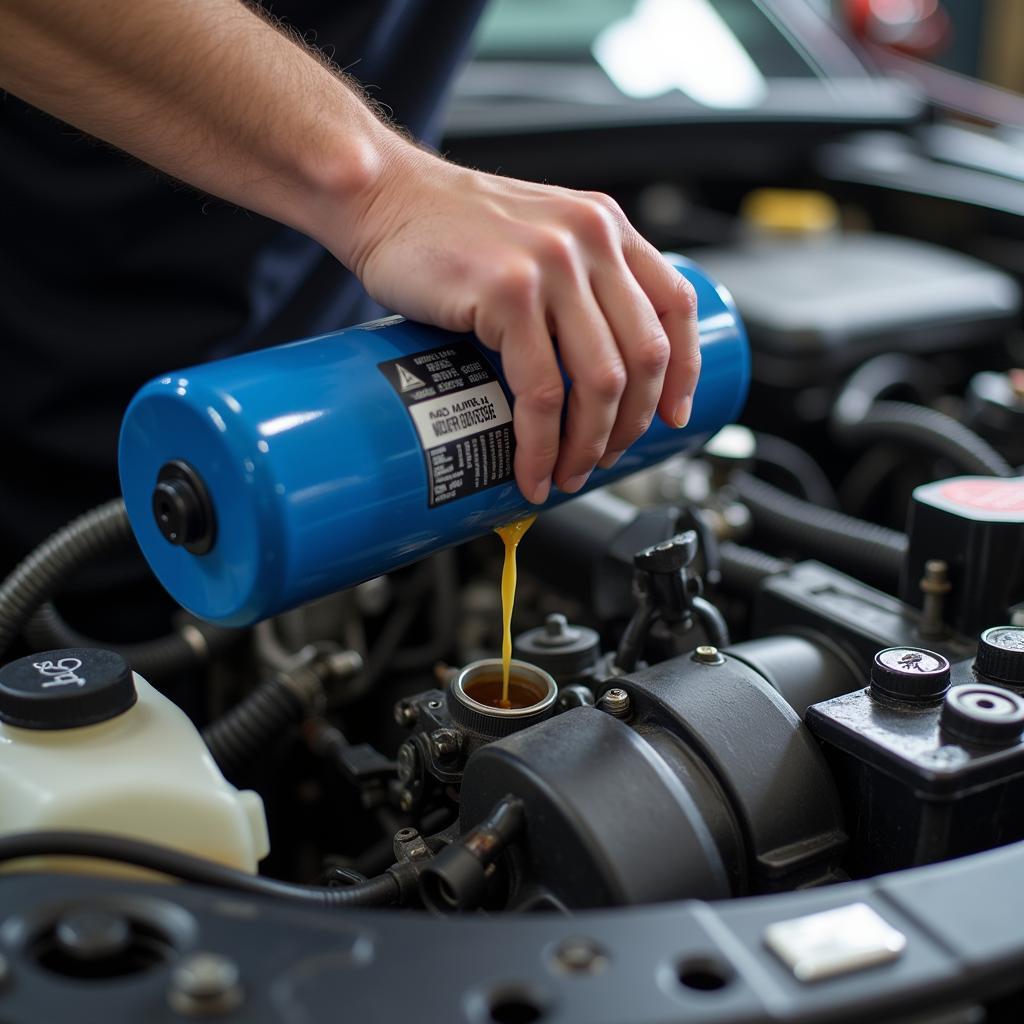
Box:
[0, 648, 269, 873]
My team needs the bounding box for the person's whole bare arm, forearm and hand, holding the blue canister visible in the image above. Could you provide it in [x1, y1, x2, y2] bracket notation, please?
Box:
[0, 0, 699, 502]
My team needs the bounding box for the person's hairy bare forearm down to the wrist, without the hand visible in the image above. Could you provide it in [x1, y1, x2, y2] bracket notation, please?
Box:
[0, 0, 395, 257]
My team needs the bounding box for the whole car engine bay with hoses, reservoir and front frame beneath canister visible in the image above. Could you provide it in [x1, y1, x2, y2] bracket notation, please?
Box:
[0, 222, 1024, 1024]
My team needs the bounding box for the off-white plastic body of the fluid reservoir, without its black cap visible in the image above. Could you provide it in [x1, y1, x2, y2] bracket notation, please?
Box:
[0, 675, 269, 873]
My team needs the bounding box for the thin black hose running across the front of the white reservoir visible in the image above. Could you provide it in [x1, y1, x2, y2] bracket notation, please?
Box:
[0, 831, 400, 907]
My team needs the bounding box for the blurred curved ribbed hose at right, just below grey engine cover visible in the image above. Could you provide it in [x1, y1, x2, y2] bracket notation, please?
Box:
[834, 401, 1015, 476]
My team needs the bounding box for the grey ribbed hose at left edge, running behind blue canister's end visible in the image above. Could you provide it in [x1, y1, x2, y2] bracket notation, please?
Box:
[0, 498, 132, 655]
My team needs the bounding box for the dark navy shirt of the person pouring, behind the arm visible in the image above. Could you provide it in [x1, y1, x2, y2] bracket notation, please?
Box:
[0, 0, 484, 585]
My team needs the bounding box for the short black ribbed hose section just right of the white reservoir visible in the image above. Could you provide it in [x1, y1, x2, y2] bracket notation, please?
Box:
[203, 678, 307, 777]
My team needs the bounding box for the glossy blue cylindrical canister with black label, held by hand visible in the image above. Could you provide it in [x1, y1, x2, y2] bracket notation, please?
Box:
[119, 257, 750, 626]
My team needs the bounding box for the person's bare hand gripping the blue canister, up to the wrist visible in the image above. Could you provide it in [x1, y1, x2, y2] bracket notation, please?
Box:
[331, 141, 700, 504]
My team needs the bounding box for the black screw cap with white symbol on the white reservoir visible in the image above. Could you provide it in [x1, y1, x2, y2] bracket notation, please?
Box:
[0, 647, 136, 729]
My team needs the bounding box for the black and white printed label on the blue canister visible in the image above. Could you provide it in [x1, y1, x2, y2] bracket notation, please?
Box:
[377, 341, 515, 508]
